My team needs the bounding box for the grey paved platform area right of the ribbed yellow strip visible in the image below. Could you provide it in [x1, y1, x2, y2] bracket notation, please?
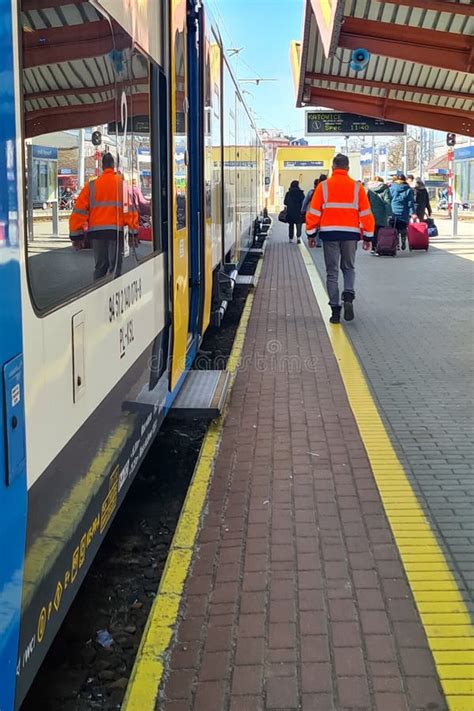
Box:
[311, 229, 474, 600]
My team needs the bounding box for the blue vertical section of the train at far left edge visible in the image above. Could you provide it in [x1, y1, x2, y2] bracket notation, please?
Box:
[0, 2, 27, 709]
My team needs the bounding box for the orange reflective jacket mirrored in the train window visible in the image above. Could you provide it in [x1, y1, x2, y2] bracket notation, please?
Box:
[69, 168, 138, 241]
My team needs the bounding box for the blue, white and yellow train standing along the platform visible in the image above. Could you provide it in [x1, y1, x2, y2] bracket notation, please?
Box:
[0, 0, 263, 711]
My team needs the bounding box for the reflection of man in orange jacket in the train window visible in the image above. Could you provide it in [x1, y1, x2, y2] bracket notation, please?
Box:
[69, 153, 138, 280]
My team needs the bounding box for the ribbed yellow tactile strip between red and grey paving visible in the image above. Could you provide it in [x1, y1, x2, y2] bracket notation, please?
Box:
[300, 245, 474, 711]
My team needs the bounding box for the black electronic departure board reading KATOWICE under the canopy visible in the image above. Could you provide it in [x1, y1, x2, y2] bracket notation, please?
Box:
[305, 110, 406, 136]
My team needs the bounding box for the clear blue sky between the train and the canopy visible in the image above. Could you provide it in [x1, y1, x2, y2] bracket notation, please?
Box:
[206, 0, 304, 138]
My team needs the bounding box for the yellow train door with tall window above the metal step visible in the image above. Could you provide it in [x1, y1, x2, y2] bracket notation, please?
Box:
[170, 0, 192, 389]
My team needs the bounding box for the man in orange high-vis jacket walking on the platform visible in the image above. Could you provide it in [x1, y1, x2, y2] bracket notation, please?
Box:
[306, 153, 375, 323]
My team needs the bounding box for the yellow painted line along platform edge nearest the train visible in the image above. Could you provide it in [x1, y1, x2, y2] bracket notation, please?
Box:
[122, 282, 256, 711]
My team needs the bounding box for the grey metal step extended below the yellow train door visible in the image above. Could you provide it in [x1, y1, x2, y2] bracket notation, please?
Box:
[169, 370, 230, 419]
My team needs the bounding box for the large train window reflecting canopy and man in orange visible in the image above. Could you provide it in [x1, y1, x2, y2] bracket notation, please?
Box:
[20, 0, 164, 310]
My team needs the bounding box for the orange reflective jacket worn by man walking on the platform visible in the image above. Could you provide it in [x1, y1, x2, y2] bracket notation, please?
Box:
[306, 168, 375, 240]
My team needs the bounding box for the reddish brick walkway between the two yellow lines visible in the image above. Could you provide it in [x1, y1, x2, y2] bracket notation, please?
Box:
[156, 228, 446, 711]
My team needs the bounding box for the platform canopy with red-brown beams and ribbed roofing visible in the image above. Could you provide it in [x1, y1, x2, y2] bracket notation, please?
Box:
[291, 0, 474, 136]
